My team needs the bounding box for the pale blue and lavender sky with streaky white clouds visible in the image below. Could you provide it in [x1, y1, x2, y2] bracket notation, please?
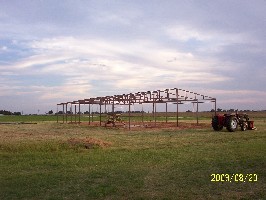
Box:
[0, 0, 266, 114]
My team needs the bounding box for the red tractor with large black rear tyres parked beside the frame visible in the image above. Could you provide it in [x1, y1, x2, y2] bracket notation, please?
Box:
[212, 112, 255, 132]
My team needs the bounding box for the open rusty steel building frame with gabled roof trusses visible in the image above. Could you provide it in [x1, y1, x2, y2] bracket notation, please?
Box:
[57, 88, 216, 129]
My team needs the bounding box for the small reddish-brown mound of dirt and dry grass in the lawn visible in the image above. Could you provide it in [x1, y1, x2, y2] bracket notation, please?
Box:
[68, 138, 111, 149]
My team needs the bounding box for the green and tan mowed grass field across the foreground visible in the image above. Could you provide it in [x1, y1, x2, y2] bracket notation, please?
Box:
[0, 115, 266, 199]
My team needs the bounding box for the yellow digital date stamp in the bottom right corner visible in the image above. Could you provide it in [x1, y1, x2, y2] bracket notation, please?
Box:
[211, 173, 258, 183]
